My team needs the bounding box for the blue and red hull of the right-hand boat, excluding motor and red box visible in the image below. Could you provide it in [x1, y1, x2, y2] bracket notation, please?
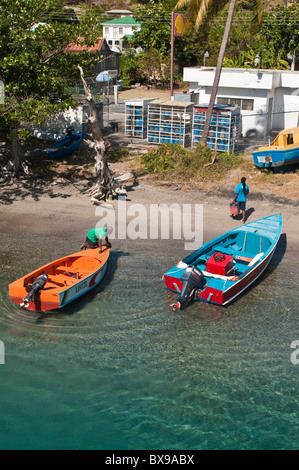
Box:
[164, 216, 282, 306]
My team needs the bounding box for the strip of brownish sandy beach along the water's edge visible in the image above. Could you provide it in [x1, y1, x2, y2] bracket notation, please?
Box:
[0, 179, 299, 259]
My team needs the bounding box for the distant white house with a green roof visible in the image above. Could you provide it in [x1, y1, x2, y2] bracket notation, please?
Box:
[101, 16, 141, 52]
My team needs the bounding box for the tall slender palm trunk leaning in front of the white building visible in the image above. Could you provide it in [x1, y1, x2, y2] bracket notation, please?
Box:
[201, 0, 236, 145]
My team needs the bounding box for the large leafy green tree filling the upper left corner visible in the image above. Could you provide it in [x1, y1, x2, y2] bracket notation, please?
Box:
[0, 0, 102, 172]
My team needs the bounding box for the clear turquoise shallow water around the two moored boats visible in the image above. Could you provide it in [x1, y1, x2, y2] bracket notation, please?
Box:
[0, 234, 299, 450]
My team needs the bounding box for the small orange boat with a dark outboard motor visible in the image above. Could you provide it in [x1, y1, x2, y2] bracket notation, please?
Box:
[9, 247, 110, 312]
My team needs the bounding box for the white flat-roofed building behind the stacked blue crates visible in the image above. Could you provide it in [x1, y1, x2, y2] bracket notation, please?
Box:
[183, 67, 299, 137]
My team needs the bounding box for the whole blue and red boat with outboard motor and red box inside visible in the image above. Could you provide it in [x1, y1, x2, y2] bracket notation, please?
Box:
[164, 214, 282, 310]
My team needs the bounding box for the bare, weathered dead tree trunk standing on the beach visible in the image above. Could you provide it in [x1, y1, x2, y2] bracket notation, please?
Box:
[78, 65, 126, 202]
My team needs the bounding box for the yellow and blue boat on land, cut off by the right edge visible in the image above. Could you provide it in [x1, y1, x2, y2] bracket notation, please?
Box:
[252, 127, 299, 168]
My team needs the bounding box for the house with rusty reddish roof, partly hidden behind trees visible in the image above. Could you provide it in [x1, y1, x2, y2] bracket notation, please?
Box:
[66, 38, 119, 76]
